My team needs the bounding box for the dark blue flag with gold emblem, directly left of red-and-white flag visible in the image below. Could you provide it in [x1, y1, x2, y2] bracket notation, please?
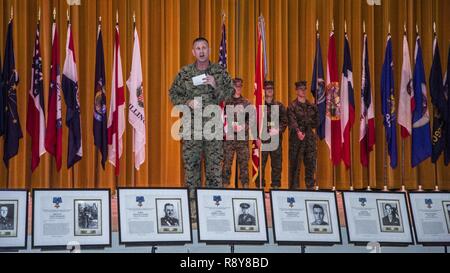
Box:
[93, 25, 108, 169]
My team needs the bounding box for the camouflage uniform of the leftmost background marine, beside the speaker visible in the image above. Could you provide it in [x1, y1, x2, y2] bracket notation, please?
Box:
[223, 96, 250, 187]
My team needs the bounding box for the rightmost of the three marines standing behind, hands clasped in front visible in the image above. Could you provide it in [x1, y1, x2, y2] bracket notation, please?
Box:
[288, 81, 319, 189]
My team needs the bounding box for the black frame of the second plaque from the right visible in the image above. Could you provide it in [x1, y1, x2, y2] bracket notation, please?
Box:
[341, 190, 414, 247]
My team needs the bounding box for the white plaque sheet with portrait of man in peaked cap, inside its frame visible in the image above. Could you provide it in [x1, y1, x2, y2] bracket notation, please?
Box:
[197, 188, 268, 245]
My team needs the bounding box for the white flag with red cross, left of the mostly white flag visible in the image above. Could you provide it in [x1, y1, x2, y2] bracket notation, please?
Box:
[108, 24, 125, 176]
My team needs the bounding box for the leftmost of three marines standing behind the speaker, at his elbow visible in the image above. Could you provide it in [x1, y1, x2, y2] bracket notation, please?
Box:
[223, 78, 250, 188]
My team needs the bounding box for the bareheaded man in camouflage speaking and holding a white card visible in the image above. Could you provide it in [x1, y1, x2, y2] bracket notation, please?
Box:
[169, 37, 233, 217]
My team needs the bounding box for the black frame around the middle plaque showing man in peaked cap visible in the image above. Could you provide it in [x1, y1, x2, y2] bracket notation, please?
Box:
[195, 187, 269, 245]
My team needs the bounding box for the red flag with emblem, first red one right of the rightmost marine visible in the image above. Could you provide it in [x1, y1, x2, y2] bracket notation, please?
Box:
[325, 32, 342, 166]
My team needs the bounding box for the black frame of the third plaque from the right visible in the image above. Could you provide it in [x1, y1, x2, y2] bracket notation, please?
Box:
[270, 189, 342, 246]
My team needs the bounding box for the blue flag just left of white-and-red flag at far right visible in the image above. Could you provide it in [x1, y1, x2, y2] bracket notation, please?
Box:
[381, 34, 397, 169]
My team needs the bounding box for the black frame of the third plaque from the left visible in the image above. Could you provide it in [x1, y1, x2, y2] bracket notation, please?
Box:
[117, 187, 193, 247]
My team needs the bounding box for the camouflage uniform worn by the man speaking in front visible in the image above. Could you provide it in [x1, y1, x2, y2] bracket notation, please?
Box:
[169, 63, 234, 198]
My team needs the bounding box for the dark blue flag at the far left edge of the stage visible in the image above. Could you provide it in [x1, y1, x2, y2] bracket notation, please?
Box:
[3, 20, 23, 167]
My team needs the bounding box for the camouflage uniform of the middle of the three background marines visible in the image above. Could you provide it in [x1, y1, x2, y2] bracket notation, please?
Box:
[256, 100, 288, 188]
